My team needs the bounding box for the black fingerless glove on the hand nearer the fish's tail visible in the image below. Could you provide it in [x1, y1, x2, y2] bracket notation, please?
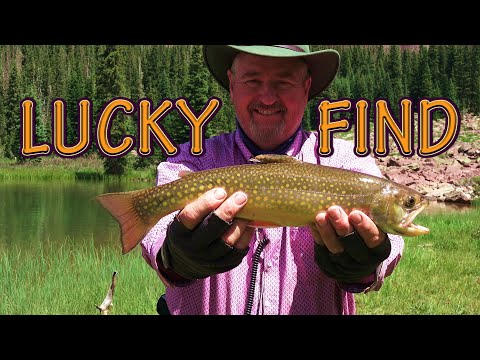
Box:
[160, 212, 248, 279]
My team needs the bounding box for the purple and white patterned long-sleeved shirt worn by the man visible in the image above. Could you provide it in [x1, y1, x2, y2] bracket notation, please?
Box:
[141, 130, 404, 315]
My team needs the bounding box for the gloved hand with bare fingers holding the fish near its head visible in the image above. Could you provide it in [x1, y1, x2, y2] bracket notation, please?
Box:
[310, 206, 391, 283]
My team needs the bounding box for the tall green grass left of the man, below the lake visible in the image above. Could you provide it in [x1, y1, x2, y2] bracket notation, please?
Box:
[0, 239, 164, 315]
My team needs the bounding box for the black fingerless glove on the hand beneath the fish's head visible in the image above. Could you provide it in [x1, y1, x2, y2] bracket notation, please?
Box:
[315, 232, 391, 283]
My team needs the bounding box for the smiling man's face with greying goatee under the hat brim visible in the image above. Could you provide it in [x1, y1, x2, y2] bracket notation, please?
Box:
[228, 53, 312, 150]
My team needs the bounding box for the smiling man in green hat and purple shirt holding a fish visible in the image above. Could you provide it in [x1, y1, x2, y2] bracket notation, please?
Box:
[142, 45, 403, 314]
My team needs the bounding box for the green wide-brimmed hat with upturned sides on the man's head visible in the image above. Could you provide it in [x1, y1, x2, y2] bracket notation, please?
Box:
[203, 45, 340, 100]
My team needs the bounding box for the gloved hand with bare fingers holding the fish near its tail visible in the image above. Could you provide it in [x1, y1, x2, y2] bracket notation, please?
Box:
[161, 188, 254, 279]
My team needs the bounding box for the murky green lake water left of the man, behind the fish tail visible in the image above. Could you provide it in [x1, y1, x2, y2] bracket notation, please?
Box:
[0, 181, 152, 248]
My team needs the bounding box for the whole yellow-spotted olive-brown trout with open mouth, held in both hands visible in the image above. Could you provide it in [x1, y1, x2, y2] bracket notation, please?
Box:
[97, 155, 429, 254]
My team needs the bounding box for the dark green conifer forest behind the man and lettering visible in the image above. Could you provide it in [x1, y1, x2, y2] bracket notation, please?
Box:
[0, 45, 480, 175]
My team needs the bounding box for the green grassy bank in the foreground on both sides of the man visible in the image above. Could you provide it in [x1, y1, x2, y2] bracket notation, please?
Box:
[0, 208, 480, 314]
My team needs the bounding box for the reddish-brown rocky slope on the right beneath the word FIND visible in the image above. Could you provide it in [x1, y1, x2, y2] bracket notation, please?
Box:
[376, 114, 480, 204]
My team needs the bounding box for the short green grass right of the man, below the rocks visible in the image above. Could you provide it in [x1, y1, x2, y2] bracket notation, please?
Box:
[356, 207, 480, 314]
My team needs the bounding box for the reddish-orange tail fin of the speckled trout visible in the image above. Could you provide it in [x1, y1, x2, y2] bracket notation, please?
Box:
[96, 191, 156, 254]
